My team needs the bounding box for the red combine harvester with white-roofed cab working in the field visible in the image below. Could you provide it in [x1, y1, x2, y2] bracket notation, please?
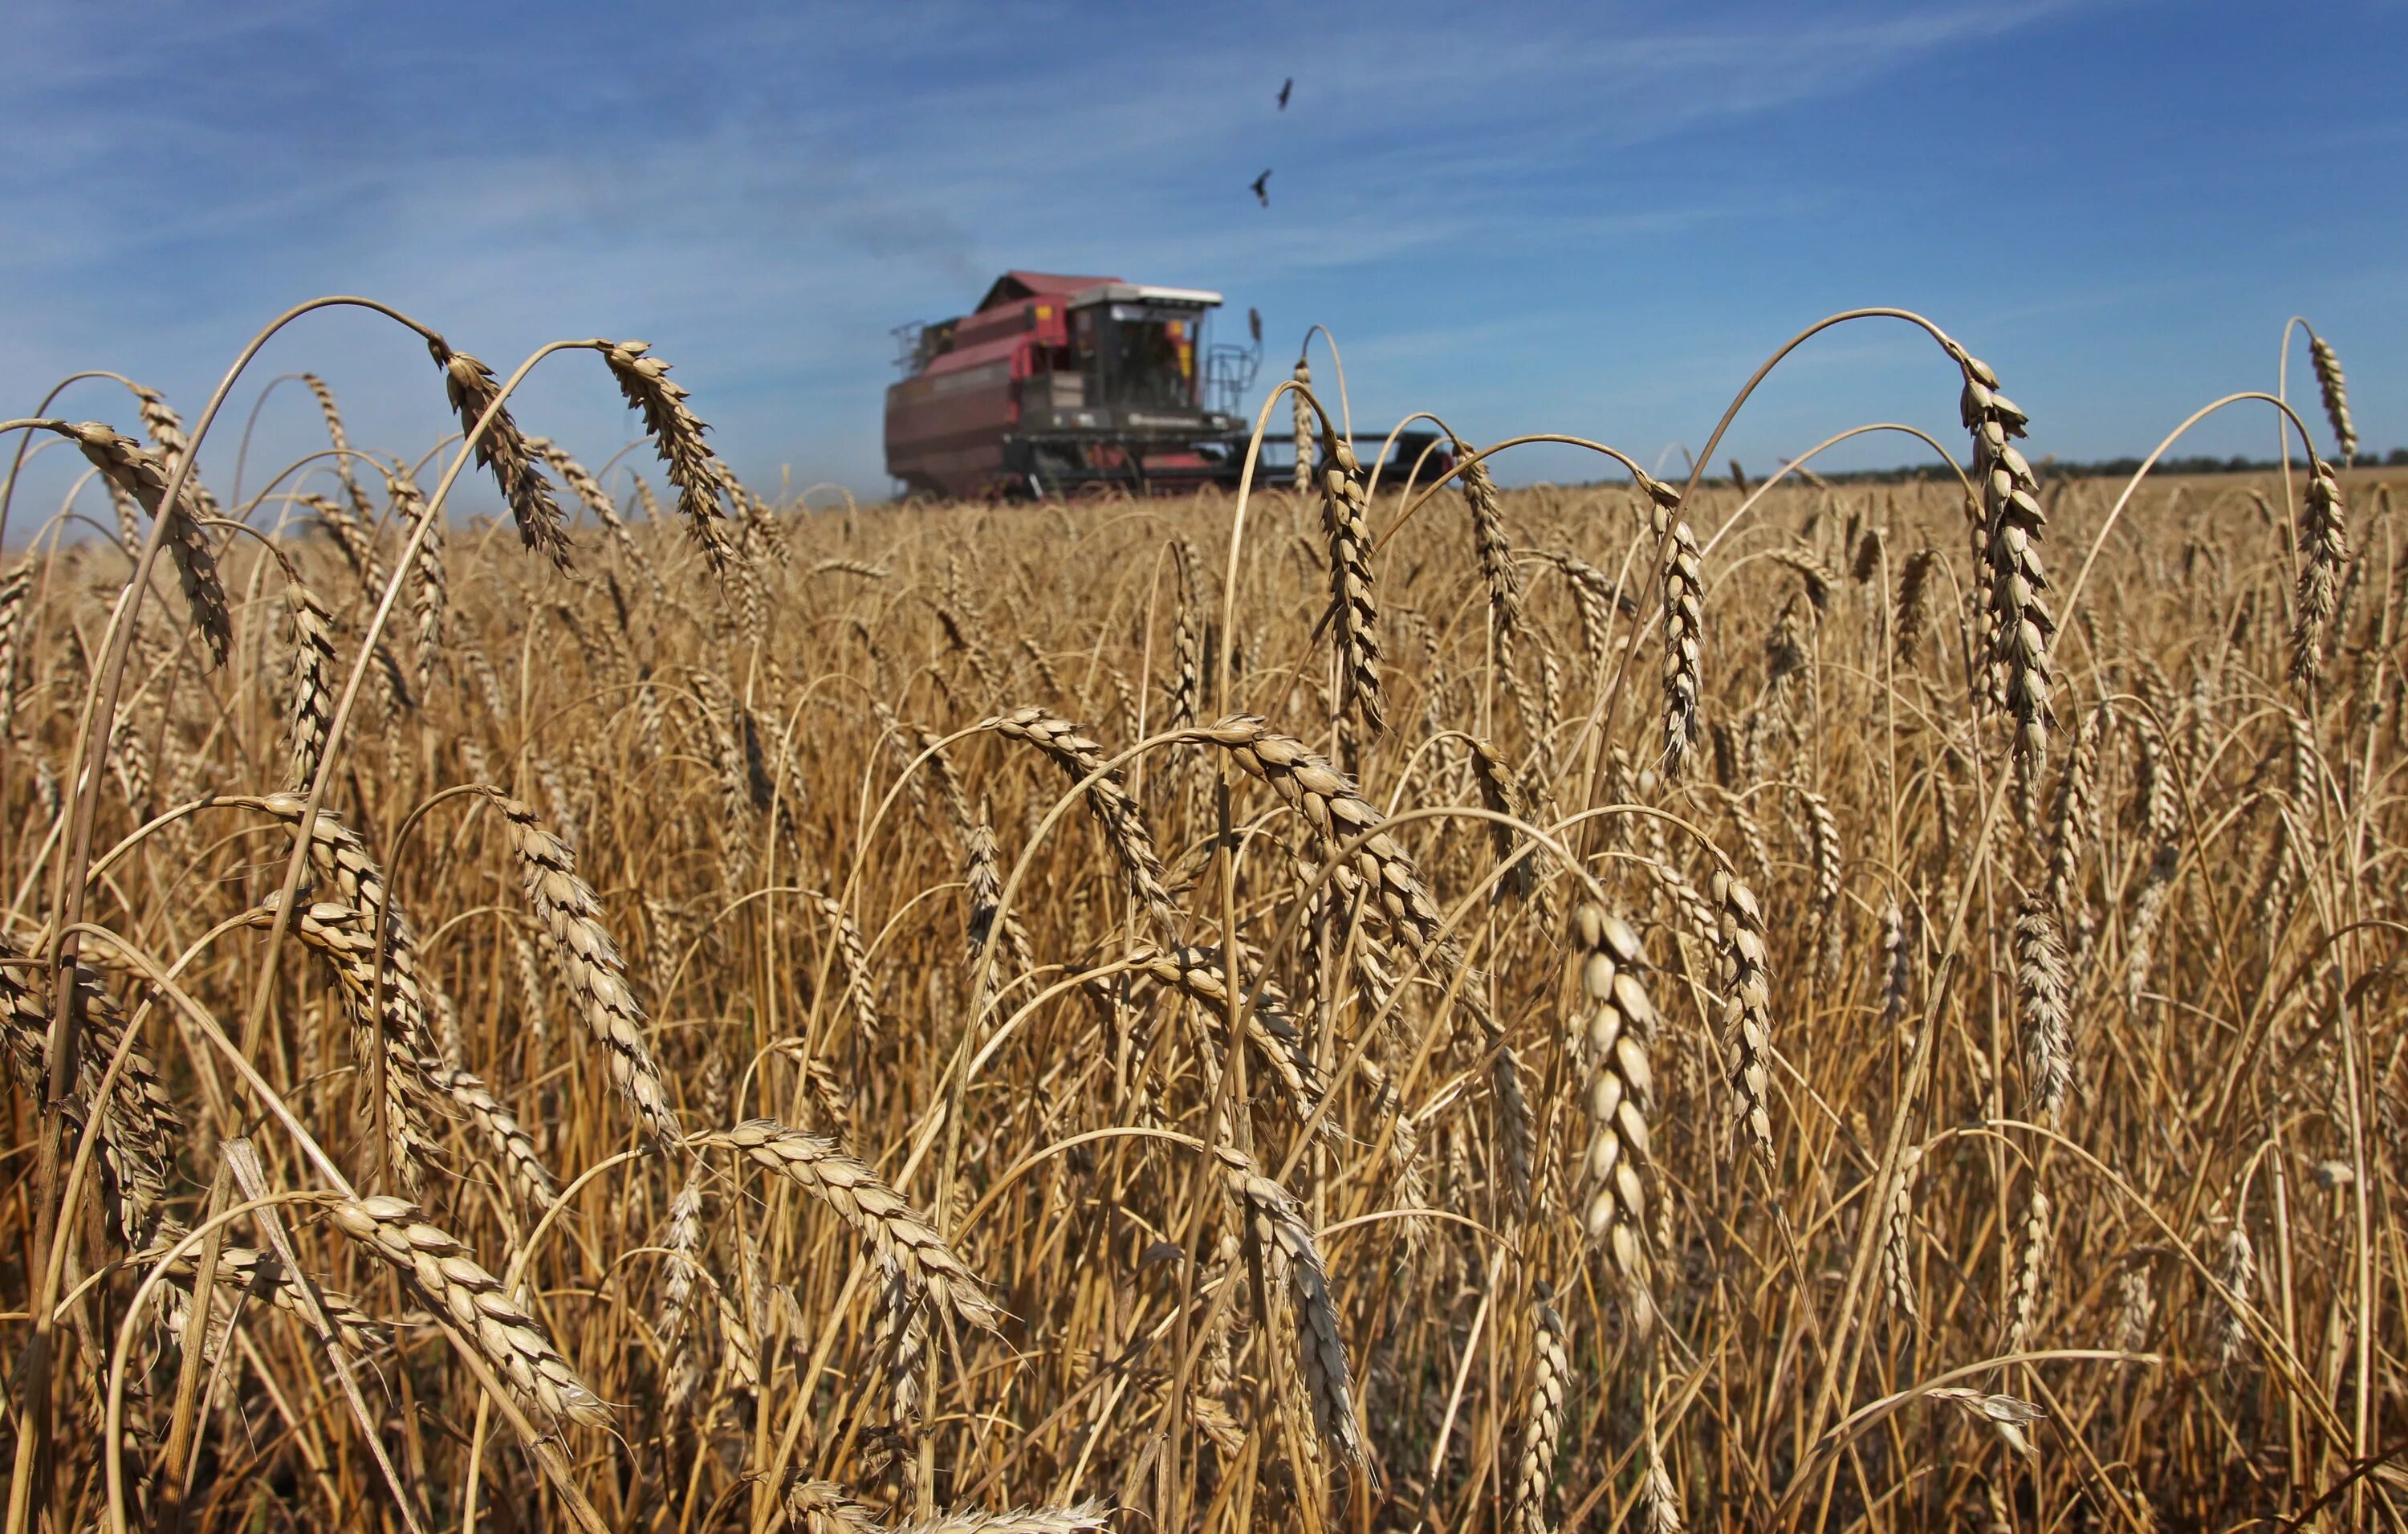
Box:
[886, 272, 1435, 498]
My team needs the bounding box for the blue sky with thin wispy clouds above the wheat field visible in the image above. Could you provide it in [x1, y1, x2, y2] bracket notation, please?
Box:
[0, 0, 2408, 515]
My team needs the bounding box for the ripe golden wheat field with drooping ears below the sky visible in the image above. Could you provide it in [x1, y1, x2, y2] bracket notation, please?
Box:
[0, 315, 2408, 1534]
